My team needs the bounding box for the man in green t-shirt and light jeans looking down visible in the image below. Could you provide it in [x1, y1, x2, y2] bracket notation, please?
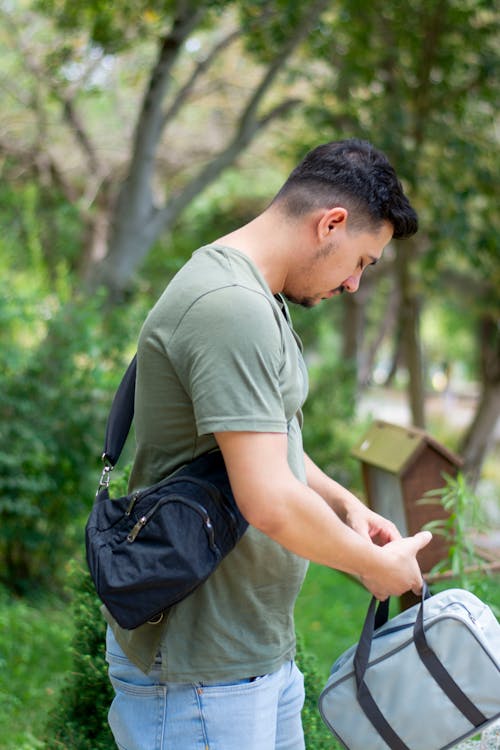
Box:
[107, 140, 430, 750]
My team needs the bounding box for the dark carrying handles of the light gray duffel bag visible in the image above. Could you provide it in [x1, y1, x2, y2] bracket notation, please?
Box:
[353, 582, 487, 750]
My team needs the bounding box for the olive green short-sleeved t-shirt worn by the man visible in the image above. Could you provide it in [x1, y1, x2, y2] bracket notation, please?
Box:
[106, 245, 307, 682]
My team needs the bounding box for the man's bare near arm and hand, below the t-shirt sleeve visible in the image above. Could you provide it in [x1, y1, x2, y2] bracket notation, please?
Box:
[215, 432, 431, 599]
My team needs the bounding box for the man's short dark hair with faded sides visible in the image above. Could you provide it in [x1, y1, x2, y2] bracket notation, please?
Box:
[273, 138, 418, 239]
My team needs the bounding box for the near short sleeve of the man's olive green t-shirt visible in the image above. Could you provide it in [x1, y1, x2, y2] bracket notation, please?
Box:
[168, 286, 287, 435]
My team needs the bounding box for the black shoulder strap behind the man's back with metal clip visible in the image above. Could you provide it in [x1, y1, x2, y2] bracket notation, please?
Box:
[97, 355, 137, 492]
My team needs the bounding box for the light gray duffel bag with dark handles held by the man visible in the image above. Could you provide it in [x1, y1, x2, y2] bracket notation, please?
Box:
[319, 586, 500, 750]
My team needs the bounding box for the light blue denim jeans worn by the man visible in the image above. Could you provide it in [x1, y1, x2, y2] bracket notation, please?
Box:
[106, 628, 305, 750]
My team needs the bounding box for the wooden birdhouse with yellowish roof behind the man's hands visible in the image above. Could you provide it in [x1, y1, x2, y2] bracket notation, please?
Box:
[352, 421, 462, 573]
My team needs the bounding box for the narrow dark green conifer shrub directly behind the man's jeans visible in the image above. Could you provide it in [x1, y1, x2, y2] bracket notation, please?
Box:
[45, 564, 115, 750]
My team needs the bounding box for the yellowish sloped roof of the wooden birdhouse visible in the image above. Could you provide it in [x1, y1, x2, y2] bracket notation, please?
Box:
[352, 420, 462, 474]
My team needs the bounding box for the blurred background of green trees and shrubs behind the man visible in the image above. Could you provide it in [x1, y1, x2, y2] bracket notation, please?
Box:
[0, 0, 500, 748]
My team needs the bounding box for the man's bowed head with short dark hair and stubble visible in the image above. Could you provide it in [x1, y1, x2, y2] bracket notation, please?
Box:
[271, 139, 418, 307]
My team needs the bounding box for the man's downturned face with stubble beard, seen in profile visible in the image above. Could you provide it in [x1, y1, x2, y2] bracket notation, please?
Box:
[283, 222, 393, 307]
